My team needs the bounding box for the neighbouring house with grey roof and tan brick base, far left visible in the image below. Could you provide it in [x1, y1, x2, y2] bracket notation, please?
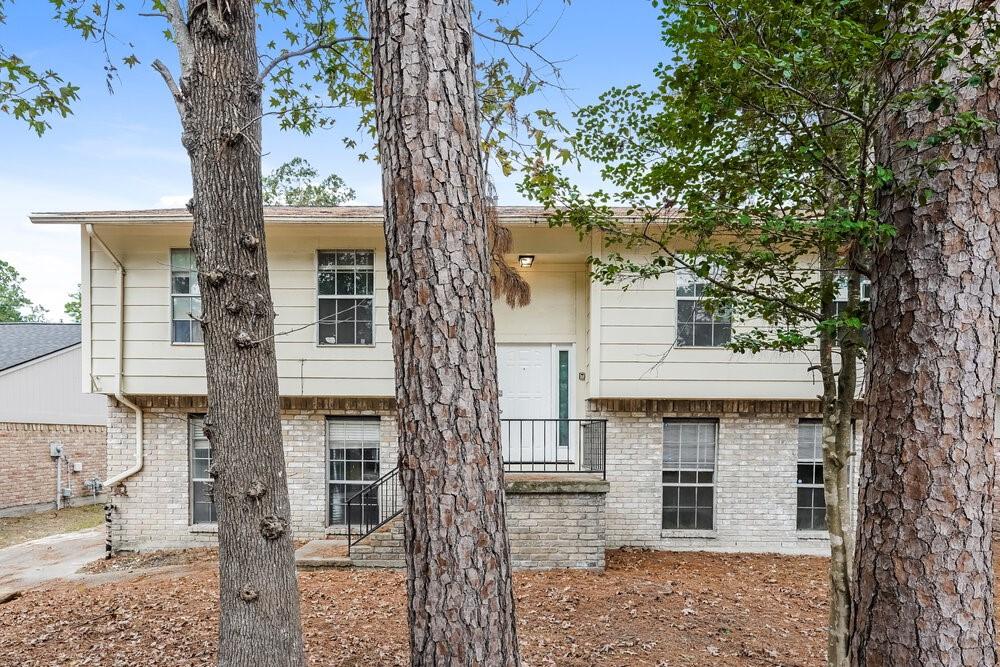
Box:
[0, 323, 107, 516]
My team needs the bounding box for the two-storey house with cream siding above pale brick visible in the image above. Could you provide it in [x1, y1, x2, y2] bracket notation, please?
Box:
[32, 207, 857, 553]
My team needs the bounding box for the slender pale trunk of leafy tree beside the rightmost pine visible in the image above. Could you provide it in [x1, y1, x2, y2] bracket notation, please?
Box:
[819, 248, 854, 667]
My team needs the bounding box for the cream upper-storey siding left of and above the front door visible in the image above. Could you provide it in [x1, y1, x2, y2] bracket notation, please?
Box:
[85, 226, 587, 401]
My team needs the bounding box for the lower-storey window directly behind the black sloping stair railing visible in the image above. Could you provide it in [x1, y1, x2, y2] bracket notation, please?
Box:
[326, 417, 379, 526]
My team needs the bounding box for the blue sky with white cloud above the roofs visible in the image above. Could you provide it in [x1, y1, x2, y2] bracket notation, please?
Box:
[0, 0, 664, 320]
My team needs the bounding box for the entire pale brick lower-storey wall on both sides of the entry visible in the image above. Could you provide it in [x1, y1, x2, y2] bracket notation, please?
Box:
[108, 405, 861, 554]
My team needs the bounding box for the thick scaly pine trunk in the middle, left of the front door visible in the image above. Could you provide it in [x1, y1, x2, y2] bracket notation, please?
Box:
[368, 0, 519, 666]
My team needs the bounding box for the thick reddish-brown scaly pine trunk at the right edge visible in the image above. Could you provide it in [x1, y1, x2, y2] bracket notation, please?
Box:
[851, 0, 1000, 667]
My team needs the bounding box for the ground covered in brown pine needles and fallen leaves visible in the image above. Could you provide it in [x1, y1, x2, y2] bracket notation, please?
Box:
[0, 551, 827, 667]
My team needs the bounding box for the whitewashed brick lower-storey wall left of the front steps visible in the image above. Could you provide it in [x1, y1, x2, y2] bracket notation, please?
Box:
[108, 404, 397, 550]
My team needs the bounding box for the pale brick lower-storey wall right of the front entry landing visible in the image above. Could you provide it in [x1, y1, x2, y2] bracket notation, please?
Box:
[590, 401, 862, 554]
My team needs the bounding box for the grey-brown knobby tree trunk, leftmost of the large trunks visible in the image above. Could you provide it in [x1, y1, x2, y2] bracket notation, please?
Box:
[181, 0, 304, 667]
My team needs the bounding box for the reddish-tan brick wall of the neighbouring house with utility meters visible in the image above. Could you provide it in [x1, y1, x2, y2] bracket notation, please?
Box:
[0, 422, 107, 515]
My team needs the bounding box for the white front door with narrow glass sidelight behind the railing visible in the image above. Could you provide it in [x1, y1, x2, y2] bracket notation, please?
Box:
[497, 344, 576, 470]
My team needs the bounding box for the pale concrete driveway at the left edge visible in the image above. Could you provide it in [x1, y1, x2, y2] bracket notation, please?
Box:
[0, 528, 104, 598]
